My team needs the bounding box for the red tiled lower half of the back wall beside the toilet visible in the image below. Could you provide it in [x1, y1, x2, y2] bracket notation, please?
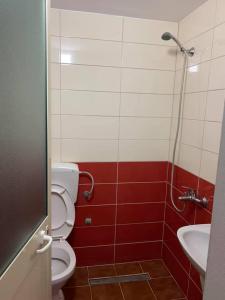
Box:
[69, 162, 168, 266]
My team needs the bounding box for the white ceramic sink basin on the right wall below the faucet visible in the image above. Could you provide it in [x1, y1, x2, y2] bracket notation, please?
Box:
[177, 224, 211, 281]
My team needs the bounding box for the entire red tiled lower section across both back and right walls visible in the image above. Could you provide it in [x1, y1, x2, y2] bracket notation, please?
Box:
[64, 162, 214, 300]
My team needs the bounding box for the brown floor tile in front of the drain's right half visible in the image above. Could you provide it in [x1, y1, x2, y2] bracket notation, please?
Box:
[121, 281, 155, 300]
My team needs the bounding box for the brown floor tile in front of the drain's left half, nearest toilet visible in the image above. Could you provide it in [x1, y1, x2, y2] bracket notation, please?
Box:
[91, 284, 123, 300]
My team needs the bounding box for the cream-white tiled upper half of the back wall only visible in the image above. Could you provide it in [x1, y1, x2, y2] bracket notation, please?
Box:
[51, 10, 178, 161]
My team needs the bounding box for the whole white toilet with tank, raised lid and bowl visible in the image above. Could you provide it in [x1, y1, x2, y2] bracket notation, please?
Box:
[51, 163, 79, 300]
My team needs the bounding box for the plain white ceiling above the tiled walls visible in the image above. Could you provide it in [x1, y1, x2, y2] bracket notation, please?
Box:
[51, 0, 207, 21]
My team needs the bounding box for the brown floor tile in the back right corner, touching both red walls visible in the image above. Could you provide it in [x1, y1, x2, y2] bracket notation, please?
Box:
[140, 260, 171, 278]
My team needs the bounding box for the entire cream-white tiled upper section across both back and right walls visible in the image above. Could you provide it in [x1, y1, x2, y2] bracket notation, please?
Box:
[50, 0, 225, 182]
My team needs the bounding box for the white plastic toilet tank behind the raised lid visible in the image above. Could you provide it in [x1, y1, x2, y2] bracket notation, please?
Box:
[51, 163, 79, 203]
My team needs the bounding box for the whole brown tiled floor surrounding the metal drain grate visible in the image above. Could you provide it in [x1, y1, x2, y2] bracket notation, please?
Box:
[64, 260, 185, 300]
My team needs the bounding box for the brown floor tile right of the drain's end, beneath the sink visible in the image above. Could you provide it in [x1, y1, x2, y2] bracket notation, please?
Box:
[150, 277, 185, 300]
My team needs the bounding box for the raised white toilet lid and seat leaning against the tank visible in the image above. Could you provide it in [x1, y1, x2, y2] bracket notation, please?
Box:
[51, 185, 75, 239]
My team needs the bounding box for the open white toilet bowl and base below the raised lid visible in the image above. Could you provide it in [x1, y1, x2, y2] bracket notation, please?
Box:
[52, 240, 76, 300]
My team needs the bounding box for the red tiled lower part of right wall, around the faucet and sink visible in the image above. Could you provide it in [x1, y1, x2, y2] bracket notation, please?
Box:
[162, 164, 214, 300]
